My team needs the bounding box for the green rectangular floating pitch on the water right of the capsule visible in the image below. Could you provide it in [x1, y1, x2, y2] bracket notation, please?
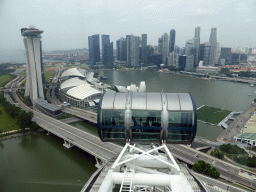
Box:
[197, 106, 231, 124]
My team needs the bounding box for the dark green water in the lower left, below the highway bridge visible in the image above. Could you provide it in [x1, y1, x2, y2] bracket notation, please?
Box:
[0, 132, 96, 192]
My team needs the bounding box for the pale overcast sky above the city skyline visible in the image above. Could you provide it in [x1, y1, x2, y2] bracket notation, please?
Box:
[0, 0, 256, 50]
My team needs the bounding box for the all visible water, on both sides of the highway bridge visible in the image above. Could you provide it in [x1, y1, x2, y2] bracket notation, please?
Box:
[0, 70, 255, 192]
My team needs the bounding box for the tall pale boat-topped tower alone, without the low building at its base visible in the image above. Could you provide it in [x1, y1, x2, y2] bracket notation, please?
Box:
[21, 26, 44, 104]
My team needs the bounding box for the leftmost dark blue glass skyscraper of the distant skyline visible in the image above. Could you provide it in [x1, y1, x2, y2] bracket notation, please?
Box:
[88, 34, 100, 68]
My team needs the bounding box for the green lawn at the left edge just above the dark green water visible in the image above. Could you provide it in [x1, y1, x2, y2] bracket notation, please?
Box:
[0, 105, 19, 133]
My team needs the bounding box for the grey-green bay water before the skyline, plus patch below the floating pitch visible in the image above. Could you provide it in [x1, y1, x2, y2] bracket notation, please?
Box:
[99, 70, 255, 139]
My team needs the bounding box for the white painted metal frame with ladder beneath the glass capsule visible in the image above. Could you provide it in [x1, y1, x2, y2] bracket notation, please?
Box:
[99, 143, 193, 192]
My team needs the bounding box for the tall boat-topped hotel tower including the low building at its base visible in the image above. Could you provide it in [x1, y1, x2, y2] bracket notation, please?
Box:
[21, 25, 61, 117]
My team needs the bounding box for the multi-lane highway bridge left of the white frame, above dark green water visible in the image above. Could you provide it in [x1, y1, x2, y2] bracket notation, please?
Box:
[9, 83, 123, 161]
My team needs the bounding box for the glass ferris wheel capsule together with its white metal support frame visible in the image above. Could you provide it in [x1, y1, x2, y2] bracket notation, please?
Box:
[91, 92, 200, 192]
